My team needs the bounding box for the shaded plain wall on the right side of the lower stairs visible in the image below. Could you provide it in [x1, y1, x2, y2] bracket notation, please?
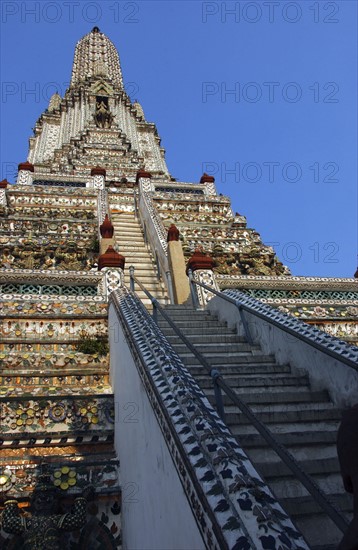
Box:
[208, 297, 358, 407]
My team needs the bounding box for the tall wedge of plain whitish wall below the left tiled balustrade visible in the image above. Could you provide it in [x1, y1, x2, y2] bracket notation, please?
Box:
[109, 305, 204, 550]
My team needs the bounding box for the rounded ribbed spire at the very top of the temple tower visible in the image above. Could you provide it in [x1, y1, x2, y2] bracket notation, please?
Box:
[71, 27, 123, 89]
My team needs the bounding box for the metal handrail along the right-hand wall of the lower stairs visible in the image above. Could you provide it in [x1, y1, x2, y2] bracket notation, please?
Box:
[189, 272, 358, 371]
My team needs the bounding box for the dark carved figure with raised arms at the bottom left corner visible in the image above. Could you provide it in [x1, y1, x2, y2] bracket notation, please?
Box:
[2, 475, 93, 550]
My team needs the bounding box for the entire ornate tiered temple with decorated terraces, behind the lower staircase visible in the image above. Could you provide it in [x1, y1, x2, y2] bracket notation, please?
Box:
[0, 27, 357, 549]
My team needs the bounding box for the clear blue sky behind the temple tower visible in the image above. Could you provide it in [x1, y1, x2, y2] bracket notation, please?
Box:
[1, 0, 357, 277]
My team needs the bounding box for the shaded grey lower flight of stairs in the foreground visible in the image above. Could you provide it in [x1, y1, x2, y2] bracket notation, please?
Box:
[158, 306, 352, 550]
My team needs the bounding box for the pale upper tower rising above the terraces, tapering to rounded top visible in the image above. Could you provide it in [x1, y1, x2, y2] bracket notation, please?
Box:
[28, 27, 168, 182]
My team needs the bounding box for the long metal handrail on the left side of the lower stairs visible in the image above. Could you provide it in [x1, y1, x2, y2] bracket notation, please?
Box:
[130, 272, 349, 533]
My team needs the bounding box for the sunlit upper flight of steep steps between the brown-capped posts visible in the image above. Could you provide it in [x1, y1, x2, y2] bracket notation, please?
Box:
[111, 212, 167, 306]
